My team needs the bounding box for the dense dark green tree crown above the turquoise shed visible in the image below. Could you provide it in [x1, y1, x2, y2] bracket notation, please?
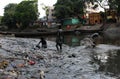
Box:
[55, 0, 84, 19]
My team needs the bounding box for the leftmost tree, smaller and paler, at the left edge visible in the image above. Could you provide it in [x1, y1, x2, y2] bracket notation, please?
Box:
[1, 3, 17, 29]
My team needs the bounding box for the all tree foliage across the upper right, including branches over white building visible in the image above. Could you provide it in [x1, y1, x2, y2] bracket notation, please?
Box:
[55, 0, 120, 21]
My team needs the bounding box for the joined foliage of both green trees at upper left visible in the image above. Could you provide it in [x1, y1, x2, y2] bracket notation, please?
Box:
[2, 0, 38, 29]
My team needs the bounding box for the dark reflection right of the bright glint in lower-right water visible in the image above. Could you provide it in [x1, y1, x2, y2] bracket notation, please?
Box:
[97, 50, 120, 76]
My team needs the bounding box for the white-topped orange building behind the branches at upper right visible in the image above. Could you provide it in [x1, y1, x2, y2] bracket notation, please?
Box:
[85, 3, 104, 24]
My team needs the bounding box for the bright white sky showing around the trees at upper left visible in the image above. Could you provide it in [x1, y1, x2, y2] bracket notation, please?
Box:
[0, 0, 57, 17]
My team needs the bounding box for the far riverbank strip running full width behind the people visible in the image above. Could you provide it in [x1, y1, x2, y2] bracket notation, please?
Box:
[0, 23, 120, 37]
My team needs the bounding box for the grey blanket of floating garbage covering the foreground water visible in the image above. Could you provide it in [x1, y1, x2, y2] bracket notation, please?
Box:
[0, 37, 120, 79]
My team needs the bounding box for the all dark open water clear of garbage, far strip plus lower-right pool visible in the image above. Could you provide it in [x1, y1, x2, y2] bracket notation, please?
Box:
[48, 31, 120, 78]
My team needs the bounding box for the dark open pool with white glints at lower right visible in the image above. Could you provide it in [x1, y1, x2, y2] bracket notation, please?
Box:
[91, 50, 120, 78]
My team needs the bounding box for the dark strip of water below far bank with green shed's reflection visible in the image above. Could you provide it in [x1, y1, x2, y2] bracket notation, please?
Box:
[47, 33, 120, 46]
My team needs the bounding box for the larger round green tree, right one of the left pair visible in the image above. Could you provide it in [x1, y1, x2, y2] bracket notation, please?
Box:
[15, 0, 38, 29]
